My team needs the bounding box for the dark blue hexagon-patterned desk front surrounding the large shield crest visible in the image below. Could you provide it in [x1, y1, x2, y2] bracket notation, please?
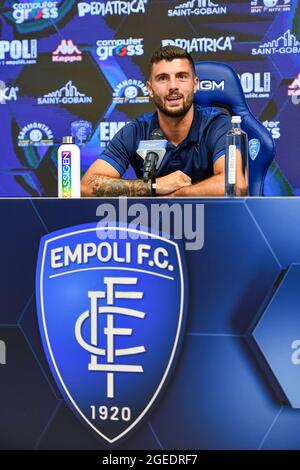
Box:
[0, 199, 300, 450]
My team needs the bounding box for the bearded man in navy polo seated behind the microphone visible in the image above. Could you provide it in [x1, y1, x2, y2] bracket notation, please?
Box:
[81, 46, 246, 197]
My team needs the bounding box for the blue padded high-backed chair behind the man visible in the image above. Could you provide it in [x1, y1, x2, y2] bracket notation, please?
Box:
[194, 62, 275, 196]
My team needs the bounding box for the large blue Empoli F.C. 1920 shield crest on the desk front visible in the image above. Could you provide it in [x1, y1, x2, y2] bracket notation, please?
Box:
[36, 224, 186, 443]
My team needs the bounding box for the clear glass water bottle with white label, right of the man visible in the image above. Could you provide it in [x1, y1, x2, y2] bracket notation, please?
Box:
[225, 116, 248, 197]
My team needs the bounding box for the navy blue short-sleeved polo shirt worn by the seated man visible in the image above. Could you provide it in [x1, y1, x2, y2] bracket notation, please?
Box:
[100, 105, 231, 183]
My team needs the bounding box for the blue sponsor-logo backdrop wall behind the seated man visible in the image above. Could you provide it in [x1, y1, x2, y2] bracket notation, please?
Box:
[0, 0, 300, 197]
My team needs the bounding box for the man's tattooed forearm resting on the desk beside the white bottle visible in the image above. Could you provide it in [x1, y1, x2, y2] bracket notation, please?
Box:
[88, 175, 151, 197]
